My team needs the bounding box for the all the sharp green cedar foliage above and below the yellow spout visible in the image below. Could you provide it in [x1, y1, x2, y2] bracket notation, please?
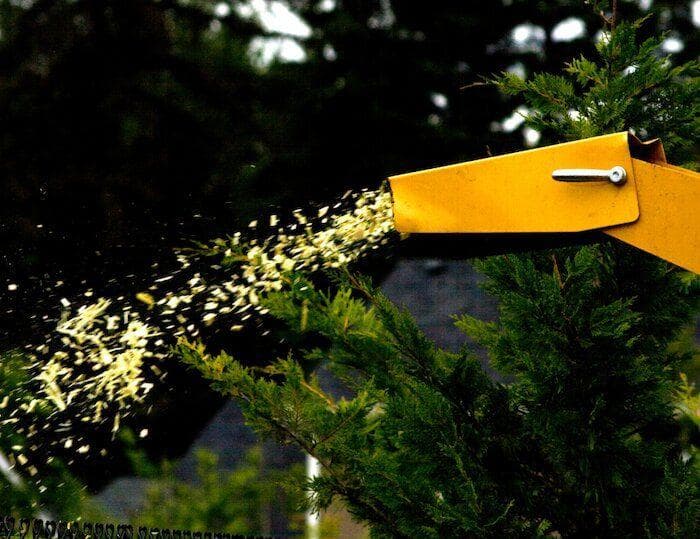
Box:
[180, 6, 700, 537]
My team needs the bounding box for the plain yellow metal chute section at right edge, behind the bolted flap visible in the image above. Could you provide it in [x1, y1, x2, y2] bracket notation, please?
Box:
[604, 159, 700, 273]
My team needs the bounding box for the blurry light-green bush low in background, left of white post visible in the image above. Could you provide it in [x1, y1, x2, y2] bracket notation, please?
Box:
[129, 447, 303, 534]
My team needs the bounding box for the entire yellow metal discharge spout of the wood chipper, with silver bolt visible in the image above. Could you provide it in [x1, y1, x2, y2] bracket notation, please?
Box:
[389, 133, 700, 273]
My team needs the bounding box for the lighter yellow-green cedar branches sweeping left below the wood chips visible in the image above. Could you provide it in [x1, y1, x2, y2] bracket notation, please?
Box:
[180, 279, 535, 537]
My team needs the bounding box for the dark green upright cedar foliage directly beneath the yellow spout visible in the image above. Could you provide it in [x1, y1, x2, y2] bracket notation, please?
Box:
[458, 244, 697, 536]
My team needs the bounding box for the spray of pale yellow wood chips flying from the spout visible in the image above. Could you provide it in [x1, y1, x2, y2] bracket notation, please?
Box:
[6, 189, 393, 472]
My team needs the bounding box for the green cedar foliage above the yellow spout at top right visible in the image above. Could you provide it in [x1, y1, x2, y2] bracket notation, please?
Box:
[496, 19, 700, 165]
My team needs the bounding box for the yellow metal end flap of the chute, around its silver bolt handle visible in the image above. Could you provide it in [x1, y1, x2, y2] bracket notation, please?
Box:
[389, 133, 639, 233]
